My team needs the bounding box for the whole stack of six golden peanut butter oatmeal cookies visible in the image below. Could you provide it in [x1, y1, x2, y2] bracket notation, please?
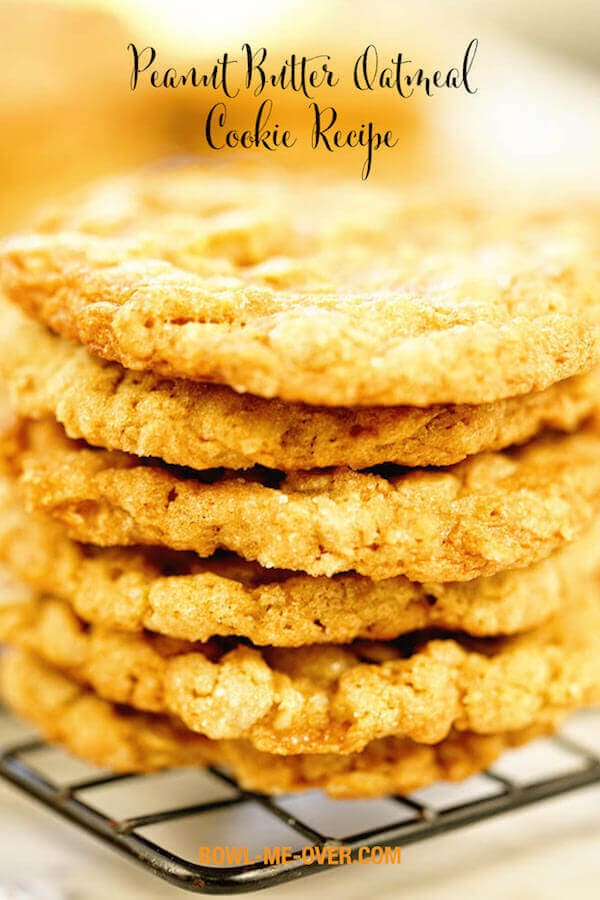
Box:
[0, 166, 600, 797]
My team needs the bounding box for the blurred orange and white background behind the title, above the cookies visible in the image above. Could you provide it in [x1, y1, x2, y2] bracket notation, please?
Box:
[0, 0, 600, 231]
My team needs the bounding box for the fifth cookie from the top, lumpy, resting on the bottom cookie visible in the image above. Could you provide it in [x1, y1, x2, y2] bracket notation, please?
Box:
[0, 581, 600, 755]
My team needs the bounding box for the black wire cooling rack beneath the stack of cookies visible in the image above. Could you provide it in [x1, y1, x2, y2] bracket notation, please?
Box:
[0, 713, 600, 894]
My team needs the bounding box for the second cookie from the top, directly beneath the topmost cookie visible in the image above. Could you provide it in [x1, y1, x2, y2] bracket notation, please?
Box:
[0, 301, 600, 471]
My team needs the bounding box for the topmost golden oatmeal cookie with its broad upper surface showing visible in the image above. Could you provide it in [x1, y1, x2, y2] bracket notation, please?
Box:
[0, 167, 600, 406]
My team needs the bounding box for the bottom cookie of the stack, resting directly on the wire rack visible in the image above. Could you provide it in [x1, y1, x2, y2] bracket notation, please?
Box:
[0, 652, 564, 799]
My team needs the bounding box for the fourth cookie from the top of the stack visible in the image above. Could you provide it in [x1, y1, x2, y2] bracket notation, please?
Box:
[0, 474, 600, 647]
